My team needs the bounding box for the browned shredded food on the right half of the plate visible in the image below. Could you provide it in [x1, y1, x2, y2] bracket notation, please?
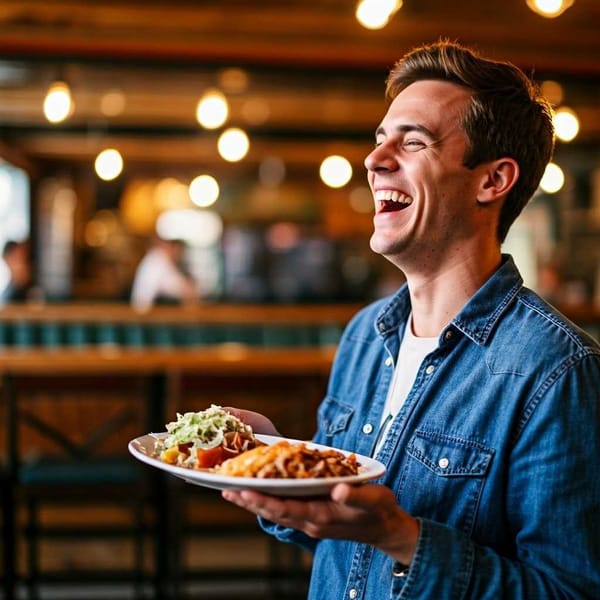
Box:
[215, 440, 360, 479]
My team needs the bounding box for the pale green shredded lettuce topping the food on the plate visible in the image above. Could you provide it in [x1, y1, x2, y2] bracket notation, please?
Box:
[162, 404, 252, 449]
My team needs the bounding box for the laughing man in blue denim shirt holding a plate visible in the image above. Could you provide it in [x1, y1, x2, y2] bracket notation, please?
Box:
[222, 42, 600, 600]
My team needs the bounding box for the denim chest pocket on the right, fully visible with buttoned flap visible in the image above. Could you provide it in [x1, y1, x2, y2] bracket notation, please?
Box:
[400, 431, 494, 533]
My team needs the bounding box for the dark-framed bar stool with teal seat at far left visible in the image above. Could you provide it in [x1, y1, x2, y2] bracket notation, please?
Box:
[2, 373, 162, 600]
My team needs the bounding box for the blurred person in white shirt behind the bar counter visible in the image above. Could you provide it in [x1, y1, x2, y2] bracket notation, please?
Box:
[131, 237, 199, 310]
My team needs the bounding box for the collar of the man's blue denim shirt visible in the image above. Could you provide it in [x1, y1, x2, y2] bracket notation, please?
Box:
[375, 254, 523, 344]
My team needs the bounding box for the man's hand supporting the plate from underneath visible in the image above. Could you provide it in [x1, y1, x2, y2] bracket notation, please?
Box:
[222, 484, 419, 564]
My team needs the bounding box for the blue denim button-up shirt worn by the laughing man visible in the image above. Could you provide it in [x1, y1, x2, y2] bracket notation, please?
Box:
[262, 256, 600, 600]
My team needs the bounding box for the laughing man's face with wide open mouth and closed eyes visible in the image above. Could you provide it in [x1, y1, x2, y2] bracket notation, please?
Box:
[365, 81, 486, 265]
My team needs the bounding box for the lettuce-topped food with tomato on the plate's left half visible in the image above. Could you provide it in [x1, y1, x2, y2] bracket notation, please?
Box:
[155, 404, 263, 469]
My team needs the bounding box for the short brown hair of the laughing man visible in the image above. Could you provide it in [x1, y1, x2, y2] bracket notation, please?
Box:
[386, 40, 554, 242]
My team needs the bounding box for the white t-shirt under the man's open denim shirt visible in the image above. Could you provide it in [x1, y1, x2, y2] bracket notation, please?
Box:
[375, 315, 438, 453]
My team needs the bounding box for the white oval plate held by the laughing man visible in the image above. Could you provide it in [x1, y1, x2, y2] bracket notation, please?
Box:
[129, 433, 385, 496]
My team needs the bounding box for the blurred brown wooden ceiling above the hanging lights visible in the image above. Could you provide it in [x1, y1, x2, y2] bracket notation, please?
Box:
[0, 0, 600, 176]
